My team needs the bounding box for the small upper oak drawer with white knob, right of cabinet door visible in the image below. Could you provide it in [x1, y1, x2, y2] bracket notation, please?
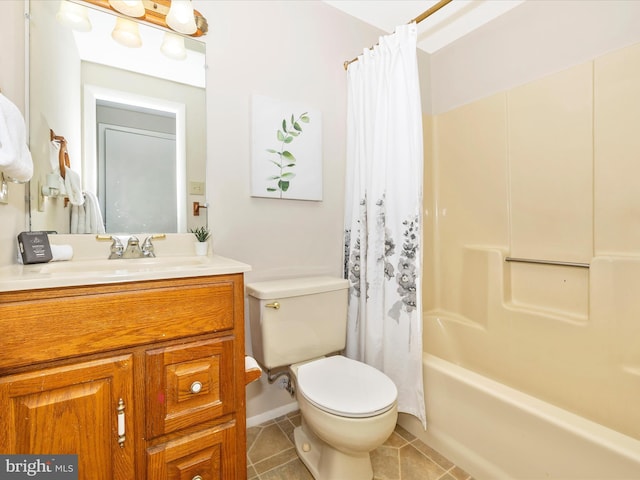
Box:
[145, 336, 235, 438]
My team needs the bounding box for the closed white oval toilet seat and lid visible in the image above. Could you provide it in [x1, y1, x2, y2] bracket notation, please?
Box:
[296, 355, 398, 418]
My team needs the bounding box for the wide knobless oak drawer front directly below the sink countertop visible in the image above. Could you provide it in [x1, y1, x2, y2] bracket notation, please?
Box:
[0, 278, 237, 371]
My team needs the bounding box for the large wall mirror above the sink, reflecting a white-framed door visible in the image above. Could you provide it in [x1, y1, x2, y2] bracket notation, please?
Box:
[27, 0, 206, 233]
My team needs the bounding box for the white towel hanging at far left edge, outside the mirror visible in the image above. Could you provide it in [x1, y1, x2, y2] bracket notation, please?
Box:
[0, 93, 33, 182]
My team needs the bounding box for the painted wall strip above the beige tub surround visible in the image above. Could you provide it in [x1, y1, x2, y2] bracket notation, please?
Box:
[431, 0, 640, 114]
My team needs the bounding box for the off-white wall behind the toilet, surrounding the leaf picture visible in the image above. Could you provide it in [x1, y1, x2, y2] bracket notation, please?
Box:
[188, 1, 388, 417]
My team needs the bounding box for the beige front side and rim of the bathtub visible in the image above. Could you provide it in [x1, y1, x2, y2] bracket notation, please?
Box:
[398, 353, 640, 480]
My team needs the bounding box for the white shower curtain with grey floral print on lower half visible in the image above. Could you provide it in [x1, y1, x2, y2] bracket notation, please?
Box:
[344, 23, 426, 427]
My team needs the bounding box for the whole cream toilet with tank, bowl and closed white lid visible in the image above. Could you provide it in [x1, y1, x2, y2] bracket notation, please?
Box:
[246, 277, 398, 480]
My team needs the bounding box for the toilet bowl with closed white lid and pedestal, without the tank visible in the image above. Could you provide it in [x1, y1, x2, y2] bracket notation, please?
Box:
[291, 355, 398, 480]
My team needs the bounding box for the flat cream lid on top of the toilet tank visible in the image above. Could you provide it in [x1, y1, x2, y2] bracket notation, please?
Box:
[246, 276, 349, 300]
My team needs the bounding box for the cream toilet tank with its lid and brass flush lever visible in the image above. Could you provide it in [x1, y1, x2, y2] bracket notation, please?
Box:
[246, 277, 349, 369]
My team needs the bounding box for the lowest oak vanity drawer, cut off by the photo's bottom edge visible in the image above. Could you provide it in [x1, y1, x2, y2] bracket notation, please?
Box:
[147, 423, 236, 480]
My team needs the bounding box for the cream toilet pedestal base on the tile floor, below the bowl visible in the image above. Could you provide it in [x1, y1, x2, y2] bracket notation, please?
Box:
[293, 417, 373, 480]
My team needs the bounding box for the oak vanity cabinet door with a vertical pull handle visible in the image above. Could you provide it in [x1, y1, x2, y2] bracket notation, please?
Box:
[0, 355, 135, 480]
